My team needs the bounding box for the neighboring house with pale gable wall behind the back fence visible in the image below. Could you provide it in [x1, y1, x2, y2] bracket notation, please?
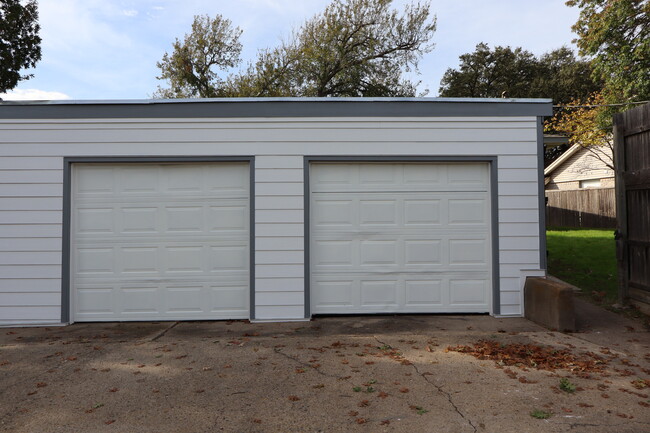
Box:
[544, 144, 614, 191]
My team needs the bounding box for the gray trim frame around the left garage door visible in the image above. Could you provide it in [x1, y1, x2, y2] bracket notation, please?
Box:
[61, 156, 255, 323]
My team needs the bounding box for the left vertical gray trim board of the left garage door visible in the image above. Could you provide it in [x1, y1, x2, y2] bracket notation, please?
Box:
[61, 158, 72, 323]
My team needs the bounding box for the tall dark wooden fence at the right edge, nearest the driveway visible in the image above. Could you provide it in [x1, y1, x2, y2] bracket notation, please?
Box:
[614, 104, 650, 312]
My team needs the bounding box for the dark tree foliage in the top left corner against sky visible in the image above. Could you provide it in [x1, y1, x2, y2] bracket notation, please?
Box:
[0, 0, 41, 93]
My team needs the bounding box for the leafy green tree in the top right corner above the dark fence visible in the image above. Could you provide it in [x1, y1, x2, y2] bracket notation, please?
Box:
[566, 0, 650, 103]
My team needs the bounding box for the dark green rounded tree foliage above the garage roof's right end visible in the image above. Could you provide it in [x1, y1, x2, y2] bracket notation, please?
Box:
[440, 43, 600, 103]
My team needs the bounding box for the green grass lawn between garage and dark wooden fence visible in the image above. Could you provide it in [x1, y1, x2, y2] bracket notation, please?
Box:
[546, 228, 618, 305]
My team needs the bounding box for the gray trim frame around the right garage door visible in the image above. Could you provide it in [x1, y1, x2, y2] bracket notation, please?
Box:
[303, 155, 501, 318]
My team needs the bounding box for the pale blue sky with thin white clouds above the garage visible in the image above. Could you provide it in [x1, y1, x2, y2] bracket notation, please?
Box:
[0, 0, 579, 100]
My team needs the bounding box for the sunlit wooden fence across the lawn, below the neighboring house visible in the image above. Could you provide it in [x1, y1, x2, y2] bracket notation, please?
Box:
[546, 188, 616, 229]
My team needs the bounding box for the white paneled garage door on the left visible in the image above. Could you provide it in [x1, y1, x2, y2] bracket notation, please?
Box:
[70, 163, 250, 321]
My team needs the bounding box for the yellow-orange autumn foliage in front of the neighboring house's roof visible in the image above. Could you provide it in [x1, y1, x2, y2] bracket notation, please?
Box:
[544, 92, 614, 170]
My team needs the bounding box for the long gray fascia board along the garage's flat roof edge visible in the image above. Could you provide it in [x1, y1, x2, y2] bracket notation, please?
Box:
[0, 98, 553, 120]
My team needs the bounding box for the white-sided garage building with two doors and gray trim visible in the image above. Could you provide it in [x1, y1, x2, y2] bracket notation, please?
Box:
[0, 98, 551, 325]
